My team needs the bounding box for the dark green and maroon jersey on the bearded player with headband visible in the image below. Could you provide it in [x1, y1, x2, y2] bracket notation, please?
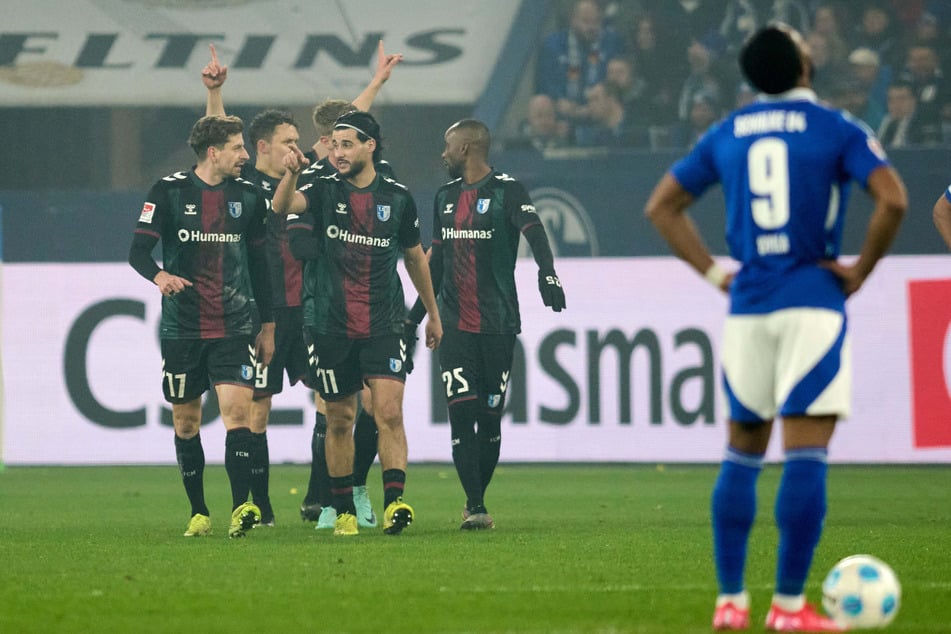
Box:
[288, 168, 419, 339]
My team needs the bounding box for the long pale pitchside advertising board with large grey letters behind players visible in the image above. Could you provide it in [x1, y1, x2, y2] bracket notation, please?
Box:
[2, 256, 951, 464]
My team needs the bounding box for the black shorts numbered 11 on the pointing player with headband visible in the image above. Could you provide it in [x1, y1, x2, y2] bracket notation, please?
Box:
[304, 327, 406, 401]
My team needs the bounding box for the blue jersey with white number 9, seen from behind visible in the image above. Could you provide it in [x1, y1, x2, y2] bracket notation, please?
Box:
[671, 88, 888, 314]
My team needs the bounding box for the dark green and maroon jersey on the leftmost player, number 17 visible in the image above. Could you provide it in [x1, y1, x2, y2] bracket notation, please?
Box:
[133, 168, 273, 339]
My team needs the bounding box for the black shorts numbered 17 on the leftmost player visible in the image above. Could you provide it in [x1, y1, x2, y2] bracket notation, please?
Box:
[162, 335, 254, 403]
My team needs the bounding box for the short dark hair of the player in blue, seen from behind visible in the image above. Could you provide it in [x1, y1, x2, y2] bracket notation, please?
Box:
[740, 25, 803, 95]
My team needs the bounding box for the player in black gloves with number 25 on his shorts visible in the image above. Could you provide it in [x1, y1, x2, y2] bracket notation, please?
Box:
[407, 119, 565, 530]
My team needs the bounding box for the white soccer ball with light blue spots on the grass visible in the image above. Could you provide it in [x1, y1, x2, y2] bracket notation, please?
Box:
[822, 555, 901, 629]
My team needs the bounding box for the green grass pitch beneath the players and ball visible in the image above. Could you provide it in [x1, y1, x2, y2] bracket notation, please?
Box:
[0, 464, 951, 634]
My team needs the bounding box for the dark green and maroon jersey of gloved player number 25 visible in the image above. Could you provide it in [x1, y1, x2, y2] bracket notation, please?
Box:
[433, 171, 540, 334]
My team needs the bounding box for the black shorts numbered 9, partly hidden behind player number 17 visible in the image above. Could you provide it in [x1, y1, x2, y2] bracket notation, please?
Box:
[254, 306, 310, 398]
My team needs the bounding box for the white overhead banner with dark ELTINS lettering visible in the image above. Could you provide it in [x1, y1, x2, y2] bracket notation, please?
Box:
[0, 0, 519, 106]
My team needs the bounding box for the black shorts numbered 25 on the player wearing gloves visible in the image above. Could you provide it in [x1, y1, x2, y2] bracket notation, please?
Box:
[439, 329, 515, 408]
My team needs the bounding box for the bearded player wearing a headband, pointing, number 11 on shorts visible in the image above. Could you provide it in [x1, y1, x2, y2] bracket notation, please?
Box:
[273, 112, 442, 535]
